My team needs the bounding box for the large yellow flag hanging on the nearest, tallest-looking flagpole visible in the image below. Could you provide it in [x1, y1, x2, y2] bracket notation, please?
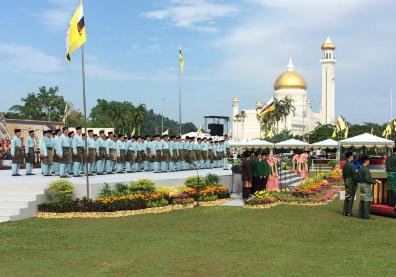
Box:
[66, 1, 87, 61]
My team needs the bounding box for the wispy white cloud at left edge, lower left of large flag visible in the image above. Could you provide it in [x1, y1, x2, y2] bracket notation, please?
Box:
[0, 43, 62, 73]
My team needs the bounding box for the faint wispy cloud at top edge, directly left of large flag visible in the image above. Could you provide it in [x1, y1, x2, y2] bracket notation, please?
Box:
[34, 0, 78, 32]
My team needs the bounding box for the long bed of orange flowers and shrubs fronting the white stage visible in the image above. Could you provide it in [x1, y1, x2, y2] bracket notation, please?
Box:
[38, 179, 230, 217]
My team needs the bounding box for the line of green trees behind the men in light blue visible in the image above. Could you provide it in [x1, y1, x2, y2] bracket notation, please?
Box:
[5, 86, 197, 135]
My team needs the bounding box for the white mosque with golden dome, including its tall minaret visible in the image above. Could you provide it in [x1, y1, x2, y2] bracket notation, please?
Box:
[232, 38, 336, 140]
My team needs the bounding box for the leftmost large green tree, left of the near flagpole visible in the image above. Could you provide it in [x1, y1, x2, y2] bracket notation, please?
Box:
[6, 86, 66, 121]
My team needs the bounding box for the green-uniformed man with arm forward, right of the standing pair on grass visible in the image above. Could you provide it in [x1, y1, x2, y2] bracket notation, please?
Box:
[356, 156, 380, 219]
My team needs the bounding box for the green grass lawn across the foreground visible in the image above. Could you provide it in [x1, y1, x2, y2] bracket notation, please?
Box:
[0, 201, 396, 276]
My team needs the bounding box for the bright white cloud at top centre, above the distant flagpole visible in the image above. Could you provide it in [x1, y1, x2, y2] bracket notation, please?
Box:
[143, 0, 238, 32]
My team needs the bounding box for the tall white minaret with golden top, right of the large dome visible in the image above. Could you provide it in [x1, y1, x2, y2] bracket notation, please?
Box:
[320, 37, 336, 124]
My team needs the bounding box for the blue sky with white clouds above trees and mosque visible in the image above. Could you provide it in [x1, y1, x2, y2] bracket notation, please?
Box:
[0, 0, 396, 125]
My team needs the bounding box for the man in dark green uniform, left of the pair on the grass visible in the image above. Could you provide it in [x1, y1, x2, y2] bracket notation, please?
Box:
[342, 152, 357, 216]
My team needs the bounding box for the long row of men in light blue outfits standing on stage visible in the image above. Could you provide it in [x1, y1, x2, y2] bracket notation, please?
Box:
[11, 127, 230, 178]
